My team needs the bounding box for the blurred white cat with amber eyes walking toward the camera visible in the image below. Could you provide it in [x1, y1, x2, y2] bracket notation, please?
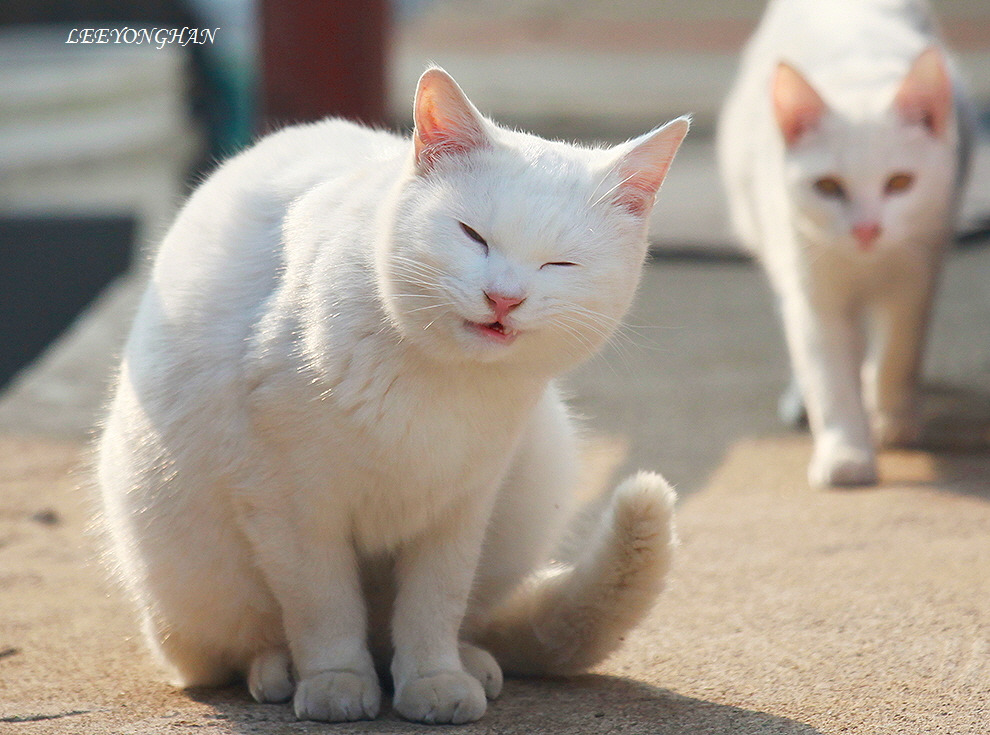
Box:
[717, 0, 966, 485]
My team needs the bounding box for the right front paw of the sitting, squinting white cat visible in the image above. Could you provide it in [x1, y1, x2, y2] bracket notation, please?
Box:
[394, 671, 488, 725]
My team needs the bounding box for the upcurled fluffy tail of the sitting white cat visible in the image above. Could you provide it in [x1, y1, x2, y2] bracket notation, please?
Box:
[477, 472, 677, 675]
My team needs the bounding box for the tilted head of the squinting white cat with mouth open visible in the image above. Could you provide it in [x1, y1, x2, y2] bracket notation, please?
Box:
[377, 68, 688, 369]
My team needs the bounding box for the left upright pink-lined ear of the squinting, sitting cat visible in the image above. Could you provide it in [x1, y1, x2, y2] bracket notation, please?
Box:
[413, 67, 489, 173]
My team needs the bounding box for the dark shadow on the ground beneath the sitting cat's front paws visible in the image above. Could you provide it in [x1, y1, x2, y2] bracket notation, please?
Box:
[190, 675, 821, 735]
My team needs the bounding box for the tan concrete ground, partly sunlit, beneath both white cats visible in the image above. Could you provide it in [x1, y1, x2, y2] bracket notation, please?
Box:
[0, 0, 990, 735]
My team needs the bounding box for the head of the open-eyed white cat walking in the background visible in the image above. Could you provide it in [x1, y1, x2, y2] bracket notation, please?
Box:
[772, 47, 956, 253]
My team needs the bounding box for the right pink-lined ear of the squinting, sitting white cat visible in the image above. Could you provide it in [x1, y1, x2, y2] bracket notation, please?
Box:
[611, 117, 691, 216]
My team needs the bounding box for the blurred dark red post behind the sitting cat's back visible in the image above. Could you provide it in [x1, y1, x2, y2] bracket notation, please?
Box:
[260, 0, 388, 131]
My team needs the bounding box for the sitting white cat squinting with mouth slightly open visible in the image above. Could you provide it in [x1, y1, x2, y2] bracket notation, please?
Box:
[99, 69, 688, 723]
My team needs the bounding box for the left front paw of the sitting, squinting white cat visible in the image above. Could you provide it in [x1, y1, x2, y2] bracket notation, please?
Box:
[293, 671, 382, 722]
